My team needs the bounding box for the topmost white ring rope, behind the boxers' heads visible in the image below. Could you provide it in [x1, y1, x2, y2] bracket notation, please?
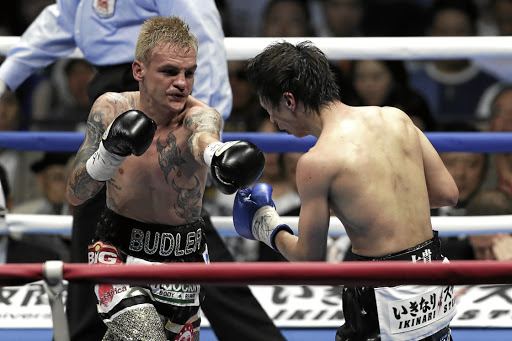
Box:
[0, 36, 512, 60]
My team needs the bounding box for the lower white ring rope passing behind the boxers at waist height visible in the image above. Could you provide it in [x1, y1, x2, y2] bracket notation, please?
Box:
[4, 214, 512, 236]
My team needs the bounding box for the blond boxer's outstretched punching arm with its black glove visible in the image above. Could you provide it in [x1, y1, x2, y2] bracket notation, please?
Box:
[185, 108, 265, 194]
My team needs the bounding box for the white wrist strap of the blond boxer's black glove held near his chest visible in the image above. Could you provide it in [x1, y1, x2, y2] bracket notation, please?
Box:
[85, 141, 126, 181]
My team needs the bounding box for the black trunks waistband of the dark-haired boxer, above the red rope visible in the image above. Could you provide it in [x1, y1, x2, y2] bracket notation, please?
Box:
[355, 230, 443, 263]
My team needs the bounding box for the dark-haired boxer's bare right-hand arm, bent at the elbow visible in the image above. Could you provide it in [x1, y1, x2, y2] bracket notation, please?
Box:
[416, 129, 459, 208]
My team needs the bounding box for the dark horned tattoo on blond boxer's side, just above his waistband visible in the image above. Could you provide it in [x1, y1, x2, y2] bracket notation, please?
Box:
[172, 176, 203, 223]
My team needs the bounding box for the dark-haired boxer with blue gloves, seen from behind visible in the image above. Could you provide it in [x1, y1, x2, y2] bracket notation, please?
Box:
[233, 42, 458, 341]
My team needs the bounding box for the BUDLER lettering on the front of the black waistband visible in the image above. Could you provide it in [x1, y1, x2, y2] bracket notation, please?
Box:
[128, 228, 201, 257]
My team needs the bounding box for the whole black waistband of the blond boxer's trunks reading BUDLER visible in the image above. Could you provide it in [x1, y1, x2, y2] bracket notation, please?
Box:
[96, 209, 206, 262]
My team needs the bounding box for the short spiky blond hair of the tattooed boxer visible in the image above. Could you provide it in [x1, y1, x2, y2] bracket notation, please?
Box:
[135, 16, 199, 64]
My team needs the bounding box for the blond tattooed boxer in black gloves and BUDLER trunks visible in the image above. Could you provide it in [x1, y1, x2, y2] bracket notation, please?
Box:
[67, 16, 264, 341]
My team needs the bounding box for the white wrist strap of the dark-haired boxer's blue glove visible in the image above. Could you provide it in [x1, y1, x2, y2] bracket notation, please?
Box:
[252, 205, 293, 251]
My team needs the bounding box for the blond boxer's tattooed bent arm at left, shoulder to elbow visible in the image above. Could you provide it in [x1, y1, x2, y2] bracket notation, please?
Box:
[66, 93, 121, 206]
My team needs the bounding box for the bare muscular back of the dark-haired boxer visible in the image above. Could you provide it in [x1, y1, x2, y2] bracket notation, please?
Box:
[311, 107, 432, 256]
